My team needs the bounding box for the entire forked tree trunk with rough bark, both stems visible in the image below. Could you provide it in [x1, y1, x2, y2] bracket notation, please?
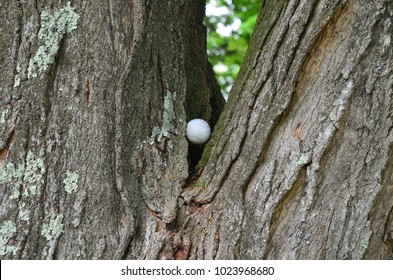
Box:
[0, 0, 393, 259]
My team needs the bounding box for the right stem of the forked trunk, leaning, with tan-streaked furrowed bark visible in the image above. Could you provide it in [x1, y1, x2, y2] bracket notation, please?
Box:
[184, 0, 393, 259]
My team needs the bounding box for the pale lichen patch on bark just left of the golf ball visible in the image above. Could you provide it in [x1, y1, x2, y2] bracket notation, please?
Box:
[150, 91, 176, 144]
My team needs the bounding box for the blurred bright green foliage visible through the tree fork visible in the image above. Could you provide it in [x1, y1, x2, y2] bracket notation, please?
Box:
[205, 0, 261, 96]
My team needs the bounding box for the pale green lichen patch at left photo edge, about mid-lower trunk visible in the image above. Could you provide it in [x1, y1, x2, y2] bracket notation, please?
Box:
[0, 151, 45, 199]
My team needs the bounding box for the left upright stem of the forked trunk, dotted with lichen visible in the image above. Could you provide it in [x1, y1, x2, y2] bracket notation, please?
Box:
[0, 0, 220, 259]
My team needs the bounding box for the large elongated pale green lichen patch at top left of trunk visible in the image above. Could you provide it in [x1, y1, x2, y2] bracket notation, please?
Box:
[28, 2, 79, 78]
